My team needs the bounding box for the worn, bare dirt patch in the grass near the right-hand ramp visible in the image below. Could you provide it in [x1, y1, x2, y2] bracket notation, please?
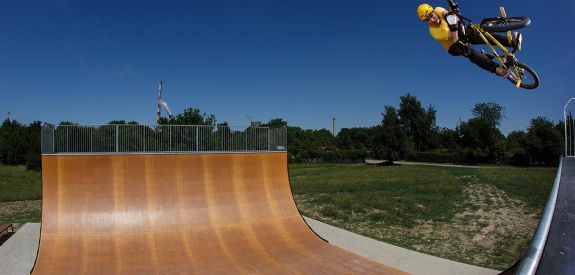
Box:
[410, 184, 538, 269]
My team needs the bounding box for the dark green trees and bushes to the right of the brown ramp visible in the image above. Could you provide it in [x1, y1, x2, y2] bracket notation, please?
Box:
[288, 94, 564, 166]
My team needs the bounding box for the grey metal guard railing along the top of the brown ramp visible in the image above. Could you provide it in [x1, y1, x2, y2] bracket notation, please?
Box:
[42, 123, 287, 154]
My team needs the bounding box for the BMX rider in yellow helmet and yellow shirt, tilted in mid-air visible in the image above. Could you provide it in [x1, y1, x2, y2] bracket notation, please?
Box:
[417, 4, 522, 78]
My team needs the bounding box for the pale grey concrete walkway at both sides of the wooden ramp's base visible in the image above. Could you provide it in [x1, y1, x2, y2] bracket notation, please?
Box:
[0, 222, 499, 275]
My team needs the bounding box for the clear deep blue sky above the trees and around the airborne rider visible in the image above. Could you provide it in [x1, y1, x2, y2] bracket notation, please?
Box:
[0, 0, 575, 133]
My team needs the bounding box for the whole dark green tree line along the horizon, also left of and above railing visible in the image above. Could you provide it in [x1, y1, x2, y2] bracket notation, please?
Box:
[0, 94, 564, 169]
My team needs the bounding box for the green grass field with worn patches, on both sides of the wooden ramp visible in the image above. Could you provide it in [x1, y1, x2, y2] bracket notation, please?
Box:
[0, 164, 556, 270]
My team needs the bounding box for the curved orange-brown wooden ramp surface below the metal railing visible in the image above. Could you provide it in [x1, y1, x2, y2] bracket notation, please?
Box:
[32, 152, 410, 274]
